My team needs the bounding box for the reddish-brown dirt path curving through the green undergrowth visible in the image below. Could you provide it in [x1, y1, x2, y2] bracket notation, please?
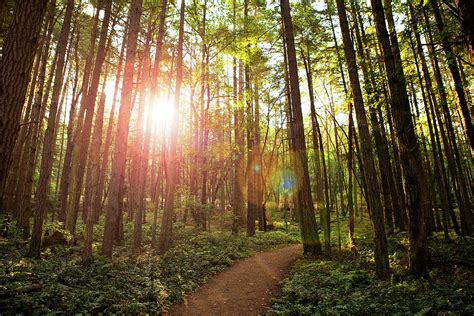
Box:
[169, 245, 303, 316]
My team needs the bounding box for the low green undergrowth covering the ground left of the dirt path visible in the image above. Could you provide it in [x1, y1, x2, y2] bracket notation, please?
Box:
[0, 216, 297, 315]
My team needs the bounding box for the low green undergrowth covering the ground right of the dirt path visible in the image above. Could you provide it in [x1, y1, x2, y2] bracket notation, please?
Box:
[271, 227, 474, 315]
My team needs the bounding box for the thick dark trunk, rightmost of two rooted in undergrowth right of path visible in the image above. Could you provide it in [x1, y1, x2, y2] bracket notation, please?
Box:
[371, 0, 431, 276]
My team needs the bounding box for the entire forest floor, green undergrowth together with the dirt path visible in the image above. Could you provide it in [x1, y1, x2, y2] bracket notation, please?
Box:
[0, 216, 474, 316]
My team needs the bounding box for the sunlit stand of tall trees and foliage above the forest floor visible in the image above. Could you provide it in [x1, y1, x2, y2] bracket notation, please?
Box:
[0, 0, 474, 312]
